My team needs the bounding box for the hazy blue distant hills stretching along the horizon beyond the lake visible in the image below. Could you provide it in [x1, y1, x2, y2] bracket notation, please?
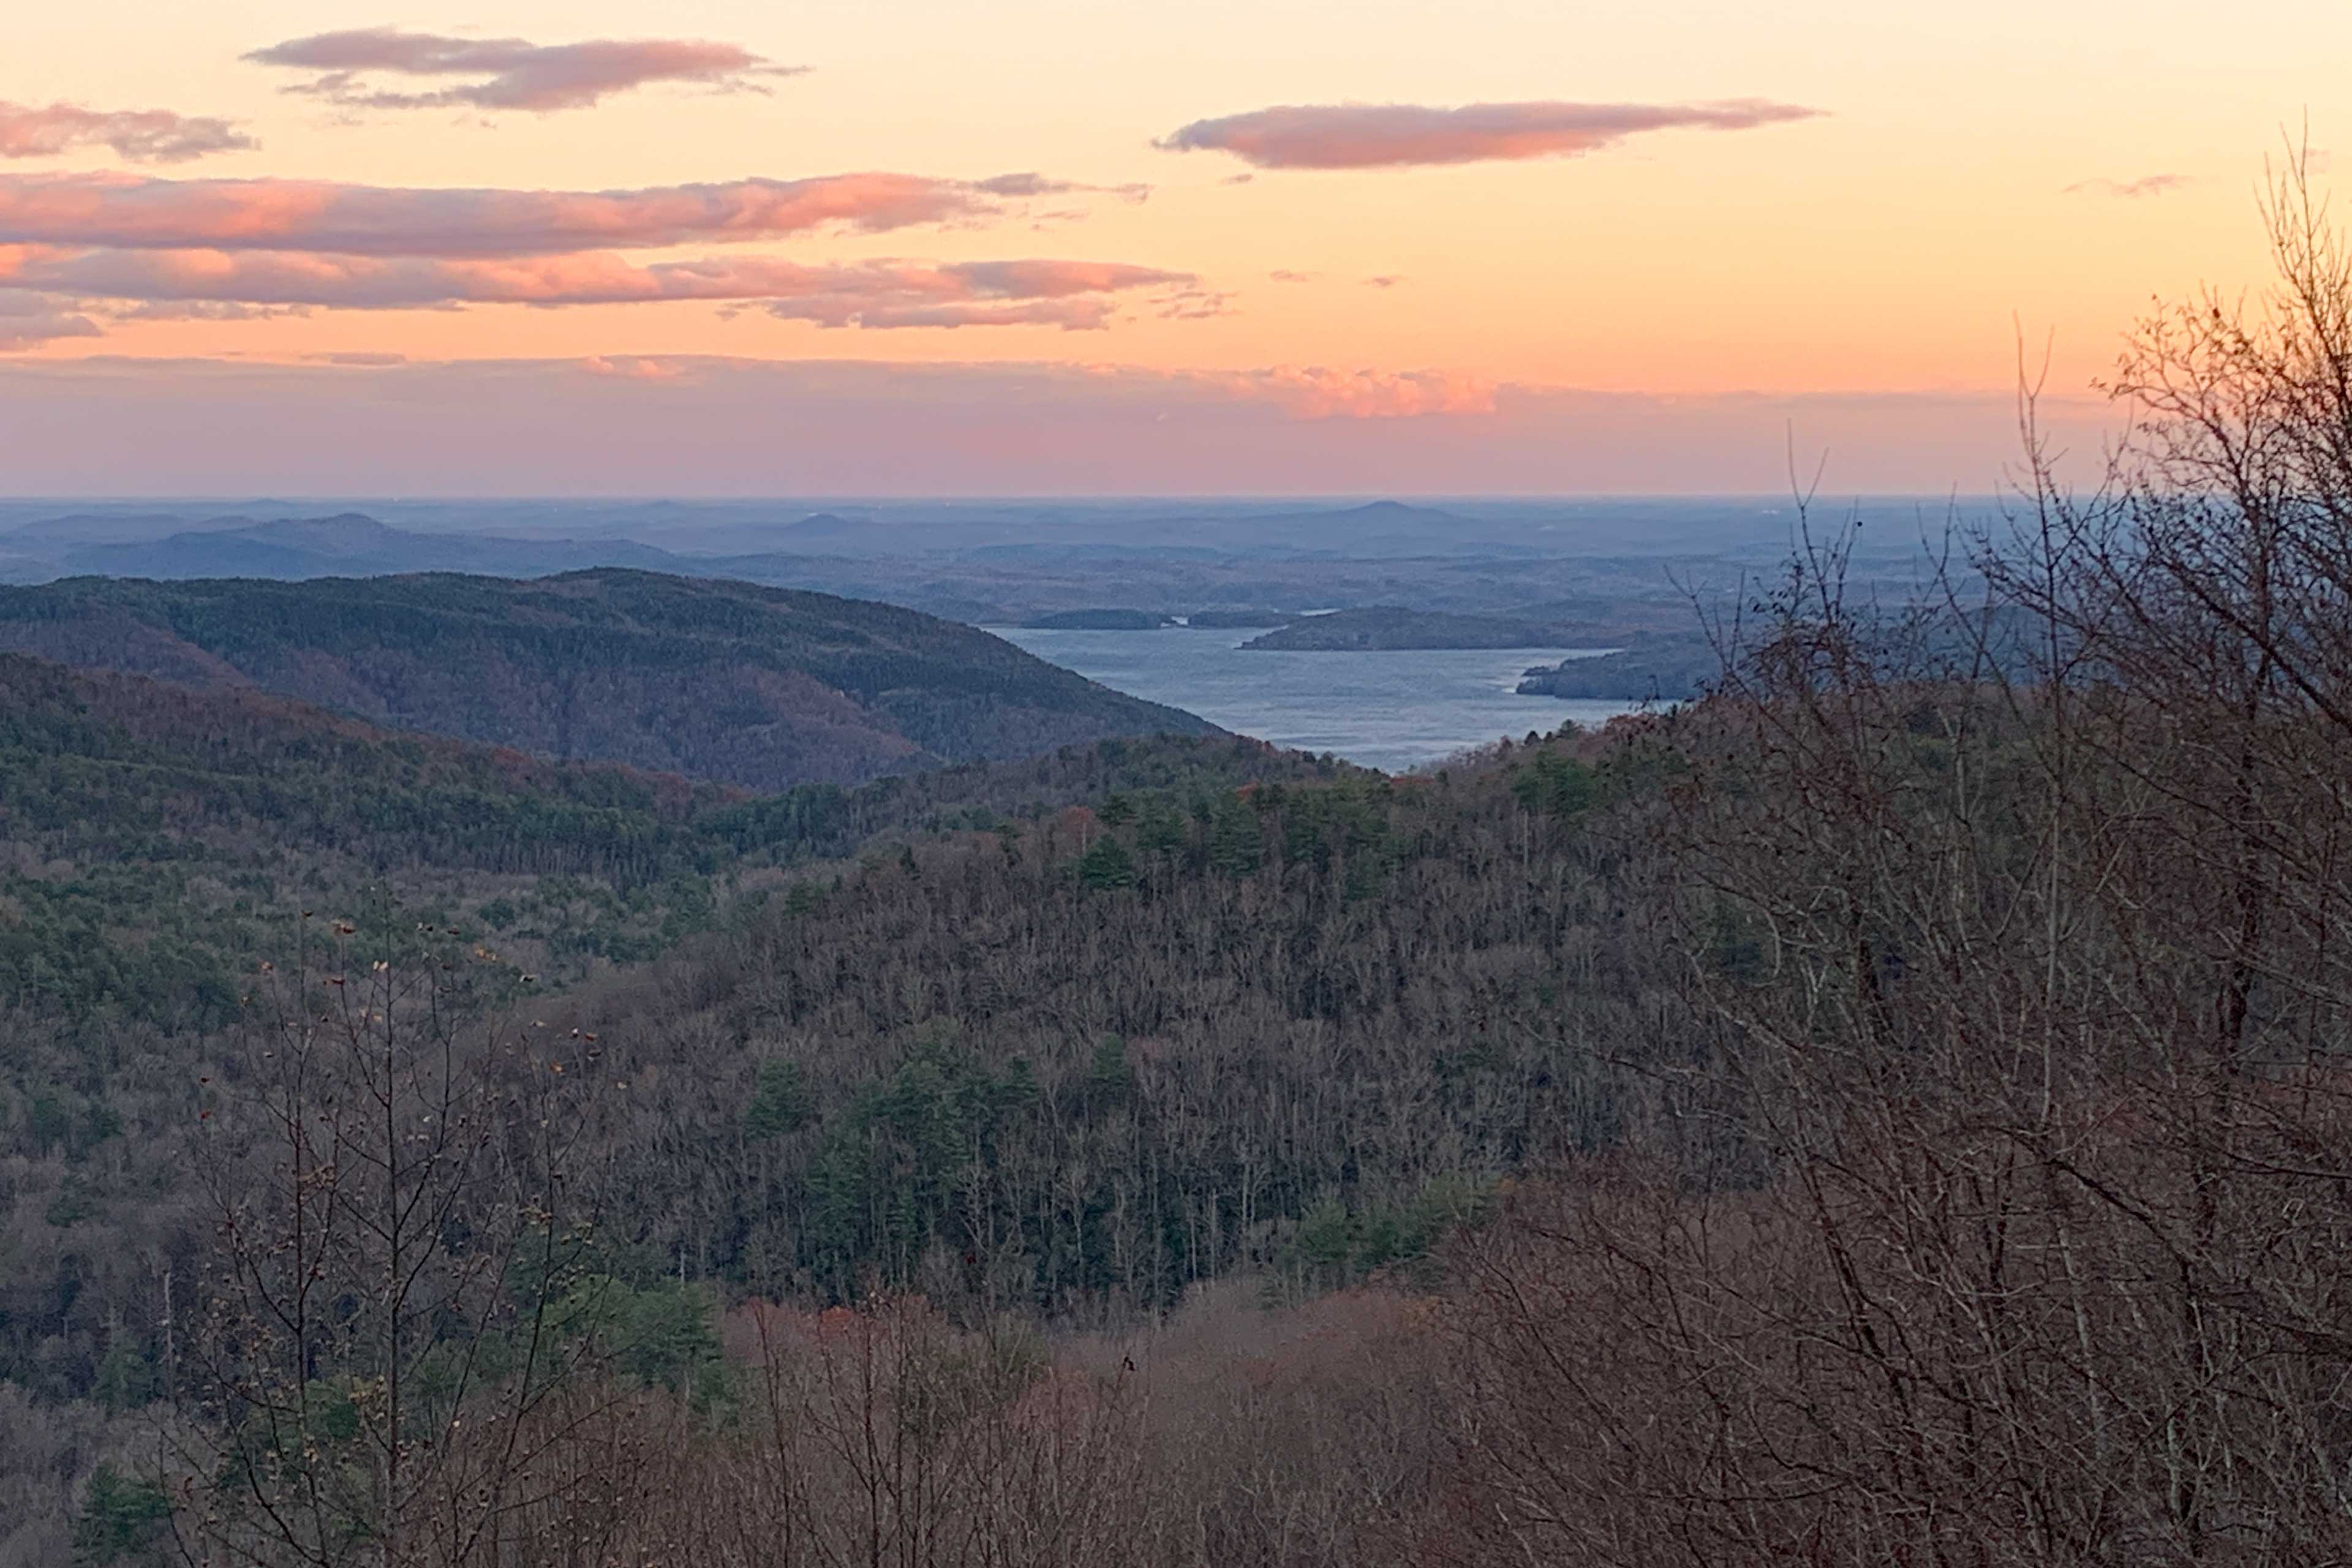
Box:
[0, 499, 1853, 646]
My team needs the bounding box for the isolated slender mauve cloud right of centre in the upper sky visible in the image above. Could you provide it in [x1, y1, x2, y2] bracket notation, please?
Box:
[1157, 99, 1820, 169]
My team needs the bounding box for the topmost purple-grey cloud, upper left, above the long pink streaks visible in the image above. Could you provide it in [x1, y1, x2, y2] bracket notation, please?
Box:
[244, 28, 804, 115]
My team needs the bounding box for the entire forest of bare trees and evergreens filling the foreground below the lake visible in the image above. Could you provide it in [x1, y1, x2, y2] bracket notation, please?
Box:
[0, 179, 2352, 1568]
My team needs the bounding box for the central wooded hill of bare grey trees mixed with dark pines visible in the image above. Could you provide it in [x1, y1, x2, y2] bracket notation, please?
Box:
[505, 741, 1665, 1321]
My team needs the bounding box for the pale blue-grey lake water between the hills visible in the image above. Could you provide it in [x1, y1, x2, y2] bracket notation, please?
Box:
[988, 625, 1635, 774]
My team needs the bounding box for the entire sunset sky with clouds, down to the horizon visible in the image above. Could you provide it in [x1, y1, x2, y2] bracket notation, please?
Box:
[0, 0, 2352, 496]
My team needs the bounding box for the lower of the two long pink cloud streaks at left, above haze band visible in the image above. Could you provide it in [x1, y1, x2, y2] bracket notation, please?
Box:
[0, 247, 1195, 331]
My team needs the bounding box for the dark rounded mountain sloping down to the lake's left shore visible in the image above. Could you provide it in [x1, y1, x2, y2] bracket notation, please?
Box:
[0, 569, 1212, 790]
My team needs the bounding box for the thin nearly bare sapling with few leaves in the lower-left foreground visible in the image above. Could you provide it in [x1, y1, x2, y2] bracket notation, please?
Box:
[188, 922, 605, 1568]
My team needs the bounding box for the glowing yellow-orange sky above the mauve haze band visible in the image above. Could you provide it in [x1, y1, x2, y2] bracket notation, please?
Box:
[0, 0, 2352, 489]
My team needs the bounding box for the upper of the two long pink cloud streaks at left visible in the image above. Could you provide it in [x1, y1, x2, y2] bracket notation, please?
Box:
[0, 174, 1058, 256]
